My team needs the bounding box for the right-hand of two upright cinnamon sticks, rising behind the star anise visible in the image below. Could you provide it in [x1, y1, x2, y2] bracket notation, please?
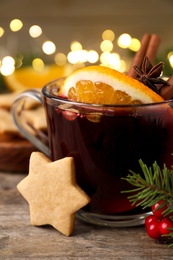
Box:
[145, 34, 161, 64]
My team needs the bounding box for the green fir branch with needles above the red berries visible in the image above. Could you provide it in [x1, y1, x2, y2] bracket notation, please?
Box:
[122, 160, 173, 215]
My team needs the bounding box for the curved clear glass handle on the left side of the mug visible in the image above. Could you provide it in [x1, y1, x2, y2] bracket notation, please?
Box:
[11, 90, 51, 158]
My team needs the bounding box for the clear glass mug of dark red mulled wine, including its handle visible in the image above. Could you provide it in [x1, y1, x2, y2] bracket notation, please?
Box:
[12, 78, 173, 227]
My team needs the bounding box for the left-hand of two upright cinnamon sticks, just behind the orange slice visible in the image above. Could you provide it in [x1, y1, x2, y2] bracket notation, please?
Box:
[127, 33, 153, 77]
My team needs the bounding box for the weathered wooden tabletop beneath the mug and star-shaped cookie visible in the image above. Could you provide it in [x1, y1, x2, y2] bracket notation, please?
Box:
[0, 172, 173, 260]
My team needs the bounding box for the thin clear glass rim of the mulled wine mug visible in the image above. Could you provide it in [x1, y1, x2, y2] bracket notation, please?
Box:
[42, 77, 173, 108]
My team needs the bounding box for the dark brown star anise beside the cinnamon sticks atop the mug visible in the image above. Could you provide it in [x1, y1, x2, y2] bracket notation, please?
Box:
[134, 57, 168, 93]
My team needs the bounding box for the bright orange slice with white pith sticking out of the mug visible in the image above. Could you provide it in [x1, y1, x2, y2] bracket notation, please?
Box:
[59, 66, 164, 104]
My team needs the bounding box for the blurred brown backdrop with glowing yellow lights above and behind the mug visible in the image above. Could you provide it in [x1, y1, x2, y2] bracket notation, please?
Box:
[0, 0, 173, 90]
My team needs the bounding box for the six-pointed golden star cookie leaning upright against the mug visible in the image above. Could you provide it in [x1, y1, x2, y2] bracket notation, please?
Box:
[17, 152, 90, 236]
